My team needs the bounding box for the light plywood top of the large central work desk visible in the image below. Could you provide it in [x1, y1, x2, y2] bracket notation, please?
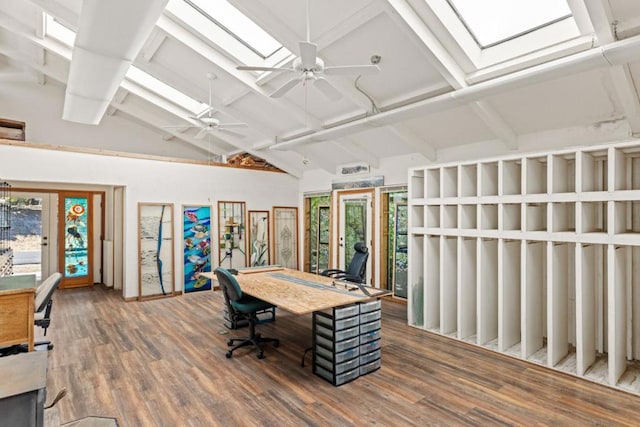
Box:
[201, 267, 378, 314]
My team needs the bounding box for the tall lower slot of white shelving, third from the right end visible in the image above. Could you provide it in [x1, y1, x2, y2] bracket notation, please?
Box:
[547, 242, 575, 367]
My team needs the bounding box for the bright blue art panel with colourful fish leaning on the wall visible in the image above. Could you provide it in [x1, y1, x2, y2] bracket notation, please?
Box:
[182, 206, 211, 293]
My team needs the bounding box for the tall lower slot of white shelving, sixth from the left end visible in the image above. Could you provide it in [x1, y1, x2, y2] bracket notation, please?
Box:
[498, 240, 522, 351]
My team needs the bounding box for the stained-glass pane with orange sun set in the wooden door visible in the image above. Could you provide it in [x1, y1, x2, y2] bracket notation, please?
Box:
[64, 197, 89, 277]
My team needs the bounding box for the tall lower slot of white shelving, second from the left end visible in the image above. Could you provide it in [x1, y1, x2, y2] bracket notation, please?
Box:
[424, 236, 440, 331]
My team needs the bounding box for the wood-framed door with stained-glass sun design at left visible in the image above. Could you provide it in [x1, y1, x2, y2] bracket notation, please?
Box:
[58, 192, 93, 287]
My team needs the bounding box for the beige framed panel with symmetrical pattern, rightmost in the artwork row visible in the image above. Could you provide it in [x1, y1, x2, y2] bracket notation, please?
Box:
[273, 206, 298, 270]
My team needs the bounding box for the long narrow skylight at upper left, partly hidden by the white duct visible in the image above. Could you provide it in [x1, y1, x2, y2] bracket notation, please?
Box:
[46, 15, 207, 114]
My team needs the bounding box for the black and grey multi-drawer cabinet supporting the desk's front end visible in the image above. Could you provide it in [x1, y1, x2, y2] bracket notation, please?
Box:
[313, 300, 382, 386]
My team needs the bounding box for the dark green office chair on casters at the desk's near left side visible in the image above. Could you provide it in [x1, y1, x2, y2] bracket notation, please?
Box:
[214, 267, 280, 359]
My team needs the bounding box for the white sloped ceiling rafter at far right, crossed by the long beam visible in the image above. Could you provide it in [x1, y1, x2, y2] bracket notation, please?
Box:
[584, 0, 640, 134]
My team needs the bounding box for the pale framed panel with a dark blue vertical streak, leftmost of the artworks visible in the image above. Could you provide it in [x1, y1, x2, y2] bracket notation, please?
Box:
[138, 203, 174, 300]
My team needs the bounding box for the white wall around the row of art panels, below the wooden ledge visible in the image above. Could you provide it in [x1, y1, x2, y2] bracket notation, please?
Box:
[0, 145, 300, 298]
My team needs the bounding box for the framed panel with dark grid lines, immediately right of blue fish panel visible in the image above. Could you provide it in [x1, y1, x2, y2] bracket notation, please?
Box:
[218, 202, 247, 268]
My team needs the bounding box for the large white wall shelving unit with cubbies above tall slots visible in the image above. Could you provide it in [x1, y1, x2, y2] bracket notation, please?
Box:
[408, 141, 640, 394]
